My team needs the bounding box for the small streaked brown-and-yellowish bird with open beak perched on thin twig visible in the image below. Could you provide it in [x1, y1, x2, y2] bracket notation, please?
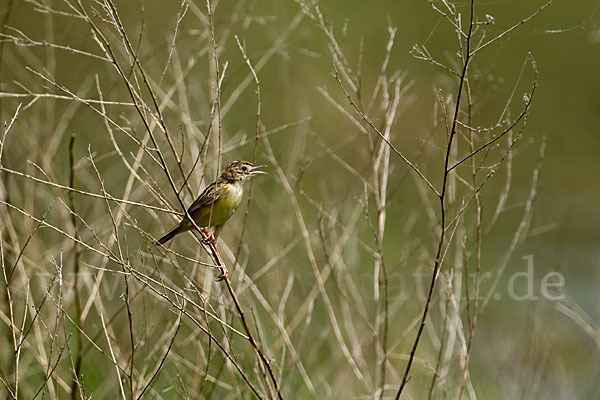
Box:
[158, 161, 266, 244]
